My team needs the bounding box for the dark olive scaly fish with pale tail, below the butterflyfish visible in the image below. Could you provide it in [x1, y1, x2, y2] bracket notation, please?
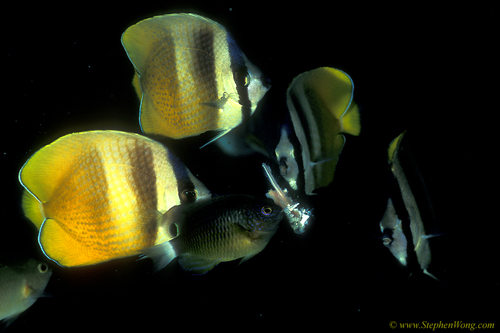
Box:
[144, 194, 283, 274]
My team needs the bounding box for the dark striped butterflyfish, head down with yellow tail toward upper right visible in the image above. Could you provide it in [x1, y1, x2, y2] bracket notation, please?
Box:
[282, 67, 361, 195]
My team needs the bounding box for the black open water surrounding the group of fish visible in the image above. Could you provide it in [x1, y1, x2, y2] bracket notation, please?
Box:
[0, 2, 500, 332]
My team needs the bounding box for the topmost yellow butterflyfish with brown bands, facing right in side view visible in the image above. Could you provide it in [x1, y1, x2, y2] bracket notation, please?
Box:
[122, 14, 269, 143]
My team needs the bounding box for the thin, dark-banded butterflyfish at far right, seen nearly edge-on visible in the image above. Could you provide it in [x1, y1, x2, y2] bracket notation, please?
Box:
[380, 131, 437, 280]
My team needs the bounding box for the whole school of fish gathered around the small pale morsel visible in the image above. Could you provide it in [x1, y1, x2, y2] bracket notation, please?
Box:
[0, 14, 442, 323]
